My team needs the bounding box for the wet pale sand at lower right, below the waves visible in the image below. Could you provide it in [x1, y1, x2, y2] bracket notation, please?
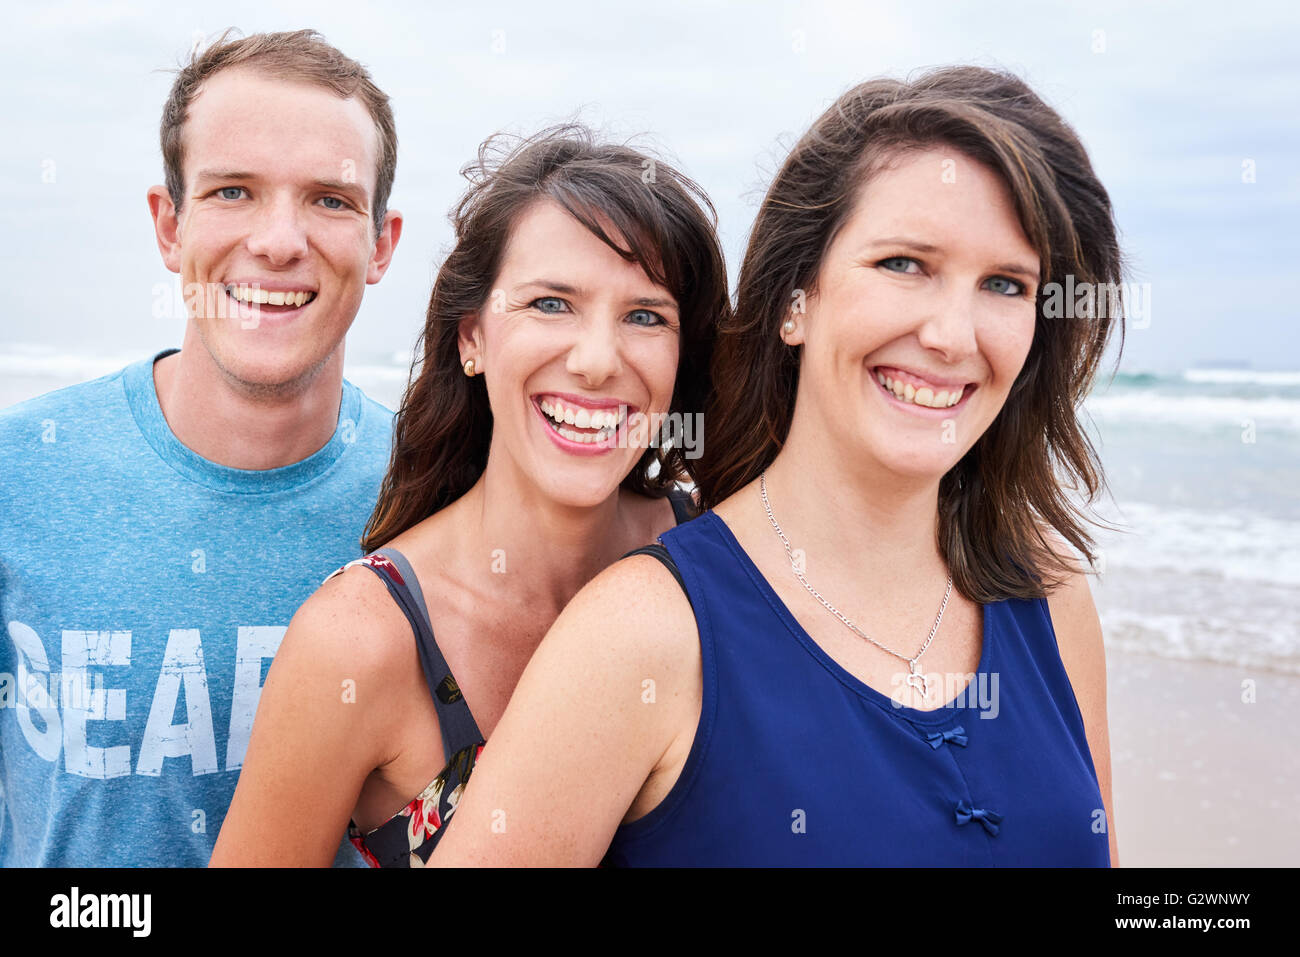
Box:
[1106, 649, 1300, 867]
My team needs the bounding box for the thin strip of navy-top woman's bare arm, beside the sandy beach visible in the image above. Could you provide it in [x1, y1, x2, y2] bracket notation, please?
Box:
[1048, 546, 1119, 867]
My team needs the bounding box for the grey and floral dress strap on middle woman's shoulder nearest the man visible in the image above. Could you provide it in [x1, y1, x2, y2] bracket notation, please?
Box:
[326, 549, 484, 761]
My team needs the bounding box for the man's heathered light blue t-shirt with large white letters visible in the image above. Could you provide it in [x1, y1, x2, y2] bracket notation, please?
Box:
[0, 350, 393, 867]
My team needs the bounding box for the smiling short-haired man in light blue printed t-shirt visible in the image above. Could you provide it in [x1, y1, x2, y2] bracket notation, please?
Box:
[0, 30, 402, 866]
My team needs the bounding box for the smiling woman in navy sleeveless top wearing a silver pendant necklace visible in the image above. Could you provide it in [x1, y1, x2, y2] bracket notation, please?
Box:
[433, 66, 1122, 866]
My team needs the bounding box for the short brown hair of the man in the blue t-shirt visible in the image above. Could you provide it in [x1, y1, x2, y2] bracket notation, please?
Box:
[160, 29, 398, 234]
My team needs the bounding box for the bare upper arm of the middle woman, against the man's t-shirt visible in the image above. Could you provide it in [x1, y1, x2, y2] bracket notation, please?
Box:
[209, 570, 411, 867]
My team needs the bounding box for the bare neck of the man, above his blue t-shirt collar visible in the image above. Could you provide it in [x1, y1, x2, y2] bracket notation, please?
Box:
[153, 322, 343, 469]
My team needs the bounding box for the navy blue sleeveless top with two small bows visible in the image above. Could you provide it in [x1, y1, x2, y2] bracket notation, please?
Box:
[605, 511, 1110, 867]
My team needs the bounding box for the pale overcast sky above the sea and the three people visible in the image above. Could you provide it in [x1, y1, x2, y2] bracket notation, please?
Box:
[0, 0, 1300, 369]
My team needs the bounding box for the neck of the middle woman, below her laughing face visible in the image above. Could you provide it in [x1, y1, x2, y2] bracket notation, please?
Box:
[462, 450, 636, 618]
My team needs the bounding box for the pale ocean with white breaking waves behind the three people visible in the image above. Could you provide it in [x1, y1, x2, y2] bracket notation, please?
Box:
[0, 345, 1300, 675]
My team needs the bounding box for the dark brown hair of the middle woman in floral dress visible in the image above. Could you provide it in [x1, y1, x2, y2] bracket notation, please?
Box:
[361, 124, 731, 551]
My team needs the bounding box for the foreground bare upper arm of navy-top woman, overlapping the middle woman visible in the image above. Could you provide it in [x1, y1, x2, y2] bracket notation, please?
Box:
[432, 555, 701, 866]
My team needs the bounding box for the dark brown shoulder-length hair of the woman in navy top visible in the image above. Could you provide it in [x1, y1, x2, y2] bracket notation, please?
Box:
[694, 66, 1123, 603]
